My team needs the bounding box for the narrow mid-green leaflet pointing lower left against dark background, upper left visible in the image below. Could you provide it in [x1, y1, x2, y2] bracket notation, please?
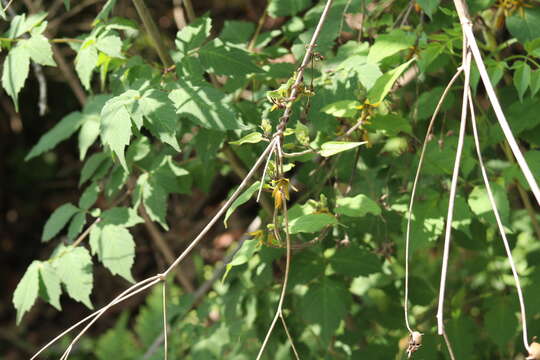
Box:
[24, 111, 84, 161]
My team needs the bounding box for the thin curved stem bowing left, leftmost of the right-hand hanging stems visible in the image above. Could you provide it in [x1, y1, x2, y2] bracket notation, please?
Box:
[403, 67, 463, 335]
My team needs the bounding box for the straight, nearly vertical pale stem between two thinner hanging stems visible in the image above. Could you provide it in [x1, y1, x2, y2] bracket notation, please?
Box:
[437, 46, 471, 335]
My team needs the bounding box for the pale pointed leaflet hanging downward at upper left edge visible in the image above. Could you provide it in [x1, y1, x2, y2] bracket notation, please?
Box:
[2, 45, 30, 112]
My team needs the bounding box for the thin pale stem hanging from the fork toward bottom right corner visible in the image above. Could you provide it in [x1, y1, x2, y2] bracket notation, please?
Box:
[467, 86, 531, 353]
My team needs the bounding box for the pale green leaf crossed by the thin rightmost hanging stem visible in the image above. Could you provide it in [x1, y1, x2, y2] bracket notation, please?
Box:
[468, 183, 510, 224]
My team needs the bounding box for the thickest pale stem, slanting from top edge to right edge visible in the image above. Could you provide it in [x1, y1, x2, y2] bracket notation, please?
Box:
[454, 0, 540, 205]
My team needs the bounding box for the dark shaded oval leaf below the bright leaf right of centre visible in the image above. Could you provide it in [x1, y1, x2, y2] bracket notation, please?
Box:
[330, 246, 382, 277]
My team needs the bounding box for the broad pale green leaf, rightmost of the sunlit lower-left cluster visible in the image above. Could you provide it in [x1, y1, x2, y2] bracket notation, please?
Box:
[90, 224, 135, 282]
